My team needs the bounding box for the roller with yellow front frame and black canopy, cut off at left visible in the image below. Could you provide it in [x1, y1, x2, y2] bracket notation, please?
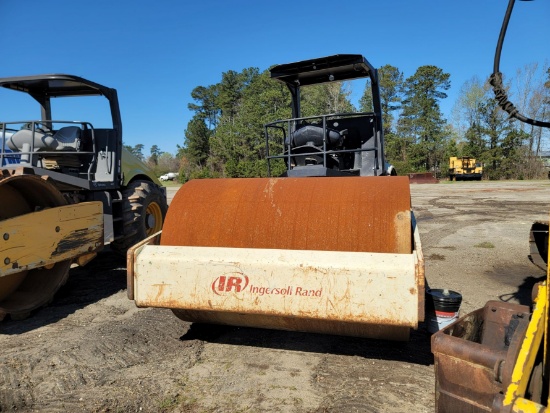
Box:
[0, 74, 167, 320]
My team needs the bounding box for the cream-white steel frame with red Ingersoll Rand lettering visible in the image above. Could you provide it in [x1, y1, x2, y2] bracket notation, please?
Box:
[128, 220, 424, 336]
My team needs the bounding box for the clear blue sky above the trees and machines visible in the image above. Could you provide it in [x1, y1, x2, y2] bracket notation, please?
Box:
[0, 0, 550, 155]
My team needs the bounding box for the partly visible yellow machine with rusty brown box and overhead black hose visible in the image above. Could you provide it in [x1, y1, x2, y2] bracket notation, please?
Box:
[432, 0, 550, 413]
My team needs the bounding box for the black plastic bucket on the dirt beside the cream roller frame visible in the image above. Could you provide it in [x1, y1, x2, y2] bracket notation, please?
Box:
[426, 289, 462, 333]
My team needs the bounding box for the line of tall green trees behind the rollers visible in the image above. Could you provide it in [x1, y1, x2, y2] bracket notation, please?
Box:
[127, 64, 550, 182]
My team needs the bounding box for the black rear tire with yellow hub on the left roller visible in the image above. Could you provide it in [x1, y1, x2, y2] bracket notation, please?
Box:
[111, 181, 168, 254]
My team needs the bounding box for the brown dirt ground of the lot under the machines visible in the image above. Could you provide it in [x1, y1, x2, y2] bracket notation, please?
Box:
[0, 181, 550, 413]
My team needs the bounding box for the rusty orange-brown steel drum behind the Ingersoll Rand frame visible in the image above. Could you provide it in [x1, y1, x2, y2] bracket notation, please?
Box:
[155, 177, 423, 340]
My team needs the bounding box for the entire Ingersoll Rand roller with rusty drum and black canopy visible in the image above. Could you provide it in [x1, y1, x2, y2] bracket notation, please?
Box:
[128, 55, 424, 340]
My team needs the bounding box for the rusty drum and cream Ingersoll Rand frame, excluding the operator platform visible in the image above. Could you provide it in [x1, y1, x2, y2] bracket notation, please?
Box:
[128, 177, 424, 340]
